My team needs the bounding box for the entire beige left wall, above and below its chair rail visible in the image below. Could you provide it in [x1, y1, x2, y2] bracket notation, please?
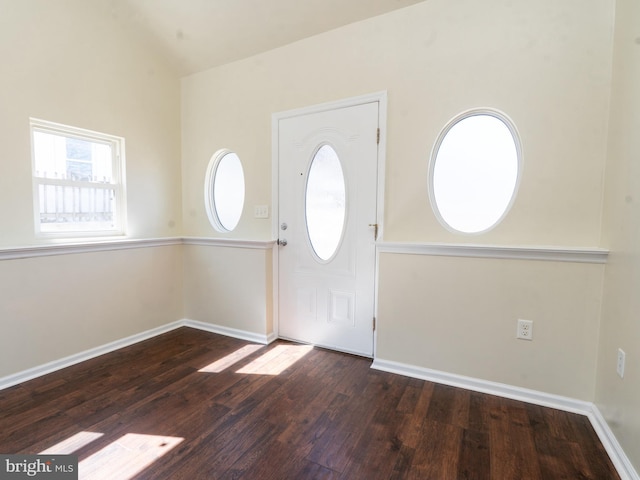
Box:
[0, 0, 182, 376]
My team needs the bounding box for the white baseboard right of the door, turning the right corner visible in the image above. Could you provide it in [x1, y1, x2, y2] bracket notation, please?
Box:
[371, 358, 640, 480]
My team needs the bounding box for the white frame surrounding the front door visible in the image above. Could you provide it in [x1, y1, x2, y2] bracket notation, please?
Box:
[271, 91, 387, 358]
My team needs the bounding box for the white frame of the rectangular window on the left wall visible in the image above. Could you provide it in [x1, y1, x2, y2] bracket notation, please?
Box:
[29, 118, 127, 240]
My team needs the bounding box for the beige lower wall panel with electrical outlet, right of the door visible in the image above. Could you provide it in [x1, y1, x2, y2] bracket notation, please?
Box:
[377, 254, 604, 400]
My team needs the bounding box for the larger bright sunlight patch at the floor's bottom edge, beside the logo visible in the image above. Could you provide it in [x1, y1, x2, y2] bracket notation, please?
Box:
[78, 433, 184, 480]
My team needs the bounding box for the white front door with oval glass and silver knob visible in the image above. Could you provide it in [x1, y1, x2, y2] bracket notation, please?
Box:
[277, 101, 379, 356]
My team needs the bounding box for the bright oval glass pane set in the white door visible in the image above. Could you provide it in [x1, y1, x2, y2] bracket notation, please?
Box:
[305, 145, 347, 261]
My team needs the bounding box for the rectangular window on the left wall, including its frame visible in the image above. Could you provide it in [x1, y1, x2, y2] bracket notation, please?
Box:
[31, 119, 125, 237]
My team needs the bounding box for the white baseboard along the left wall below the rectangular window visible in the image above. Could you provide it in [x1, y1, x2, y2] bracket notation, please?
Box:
[0, 321, 183, 390]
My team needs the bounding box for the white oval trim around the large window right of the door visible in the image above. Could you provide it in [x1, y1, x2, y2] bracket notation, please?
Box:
[427, 107, 524, 236]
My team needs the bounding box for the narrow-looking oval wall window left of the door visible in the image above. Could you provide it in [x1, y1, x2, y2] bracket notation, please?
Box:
[204, 149, 245, 232]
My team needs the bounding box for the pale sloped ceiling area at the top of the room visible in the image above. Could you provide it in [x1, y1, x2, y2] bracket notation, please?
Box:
[112, 0, 424, 75]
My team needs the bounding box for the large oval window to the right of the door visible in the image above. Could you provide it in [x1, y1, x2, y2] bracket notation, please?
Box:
[429, 110, 521, 234]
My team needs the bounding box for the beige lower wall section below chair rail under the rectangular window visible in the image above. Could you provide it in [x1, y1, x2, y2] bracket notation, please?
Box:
[0, 245, 182, 378]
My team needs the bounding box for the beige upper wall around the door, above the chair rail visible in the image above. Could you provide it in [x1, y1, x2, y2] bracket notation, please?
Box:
[182, 0, 614, 246]
